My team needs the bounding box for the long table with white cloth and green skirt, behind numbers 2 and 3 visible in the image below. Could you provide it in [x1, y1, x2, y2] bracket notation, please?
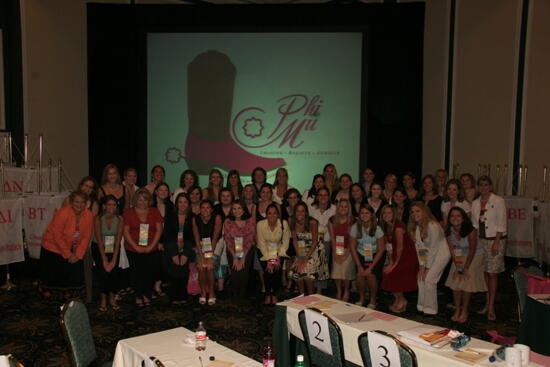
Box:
[273, 295, 538, 367]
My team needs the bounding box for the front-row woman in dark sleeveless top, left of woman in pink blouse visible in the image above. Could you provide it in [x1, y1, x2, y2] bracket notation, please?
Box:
[193, 200, 222, 305]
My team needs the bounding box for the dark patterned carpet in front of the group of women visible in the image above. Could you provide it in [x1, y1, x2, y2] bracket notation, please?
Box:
[0, 258, 528, 367]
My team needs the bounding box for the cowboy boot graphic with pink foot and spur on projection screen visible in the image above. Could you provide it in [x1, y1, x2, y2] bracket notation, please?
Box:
[166, 50, 285, 175]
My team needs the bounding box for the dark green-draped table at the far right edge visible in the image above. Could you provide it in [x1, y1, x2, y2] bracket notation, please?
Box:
[518, 294, 550, 356]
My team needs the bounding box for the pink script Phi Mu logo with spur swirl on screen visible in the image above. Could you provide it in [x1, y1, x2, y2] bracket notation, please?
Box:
[231, 94, 323, 149]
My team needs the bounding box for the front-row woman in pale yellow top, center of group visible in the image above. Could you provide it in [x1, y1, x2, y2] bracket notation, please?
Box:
[256, 203, 290, 305]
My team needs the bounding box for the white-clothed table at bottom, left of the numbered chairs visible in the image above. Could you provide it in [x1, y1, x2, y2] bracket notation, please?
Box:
[113, 327, 261, 367]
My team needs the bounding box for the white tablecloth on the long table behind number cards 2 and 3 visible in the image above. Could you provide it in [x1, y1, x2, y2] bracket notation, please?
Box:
[278, 294, 538, 367]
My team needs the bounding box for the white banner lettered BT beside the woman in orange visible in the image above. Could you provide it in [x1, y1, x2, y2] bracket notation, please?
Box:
[23, 194, 67, 259]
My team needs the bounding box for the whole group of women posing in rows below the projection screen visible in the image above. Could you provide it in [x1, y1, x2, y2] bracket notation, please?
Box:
[42, 164, 506, 322]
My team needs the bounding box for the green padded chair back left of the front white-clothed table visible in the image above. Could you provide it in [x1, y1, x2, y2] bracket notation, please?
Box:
[60, 300, 97, 367]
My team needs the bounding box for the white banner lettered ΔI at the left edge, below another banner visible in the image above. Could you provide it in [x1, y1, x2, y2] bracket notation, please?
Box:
[0, 199, 25, 265]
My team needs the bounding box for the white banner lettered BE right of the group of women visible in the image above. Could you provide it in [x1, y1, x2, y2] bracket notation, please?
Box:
[506, 197, 535, 258]
